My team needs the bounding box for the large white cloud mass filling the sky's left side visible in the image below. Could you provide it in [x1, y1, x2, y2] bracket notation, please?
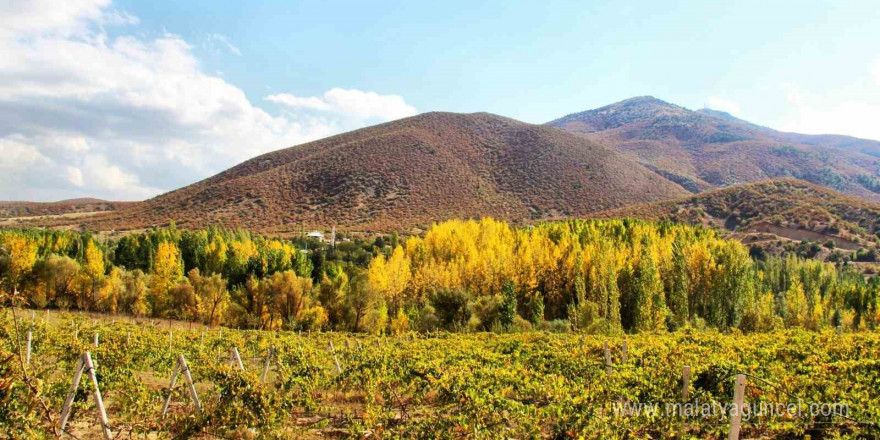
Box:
[0, 0, 415, 200]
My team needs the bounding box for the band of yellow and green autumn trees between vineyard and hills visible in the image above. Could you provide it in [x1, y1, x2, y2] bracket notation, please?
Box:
[0, 219, 880, 333]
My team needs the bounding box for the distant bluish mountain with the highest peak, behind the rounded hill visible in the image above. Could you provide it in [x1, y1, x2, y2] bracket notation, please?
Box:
[547, 96, 880, 201]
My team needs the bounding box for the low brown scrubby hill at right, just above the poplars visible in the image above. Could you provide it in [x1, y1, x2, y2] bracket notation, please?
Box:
[594, 179, 880, 250]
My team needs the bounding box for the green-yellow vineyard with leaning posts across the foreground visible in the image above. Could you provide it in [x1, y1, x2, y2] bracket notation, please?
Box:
[0, 309, 880, 439]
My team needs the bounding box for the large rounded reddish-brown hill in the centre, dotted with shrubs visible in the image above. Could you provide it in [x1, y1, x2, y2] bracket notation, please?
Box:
[55, 113, 688, 232]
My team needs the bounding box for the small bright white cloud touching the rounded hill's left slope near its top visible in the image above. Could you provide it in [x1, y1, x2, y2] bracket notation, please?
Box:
[266, 88, 416, 122]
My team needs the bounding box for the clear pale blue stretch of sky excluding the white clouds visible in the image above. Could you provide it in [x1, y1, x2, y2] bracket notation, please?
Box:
[118, 0, 880, 125]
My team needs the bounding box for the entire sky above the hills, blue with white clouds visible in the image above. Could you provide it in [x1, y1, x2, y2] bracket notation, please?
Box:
[0, 0, 880, 201]
